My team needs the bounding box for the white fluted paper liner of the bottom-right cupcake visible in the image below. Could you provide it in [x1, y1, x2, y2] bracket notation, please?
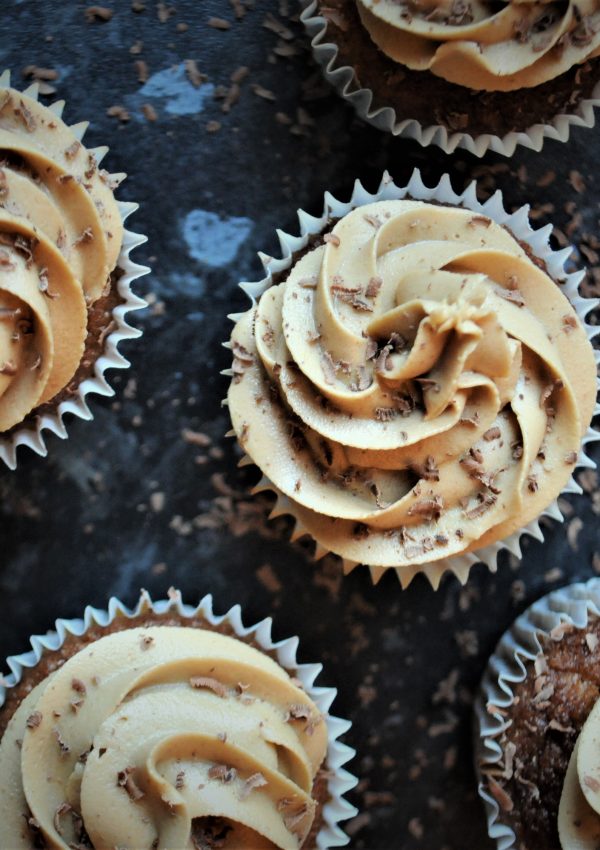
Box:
[475, 578, 600, 850]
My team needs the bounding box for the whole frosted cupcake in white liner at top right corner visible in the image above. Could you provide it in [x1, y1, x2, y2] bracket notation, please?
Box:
[303, 0, 600, 155]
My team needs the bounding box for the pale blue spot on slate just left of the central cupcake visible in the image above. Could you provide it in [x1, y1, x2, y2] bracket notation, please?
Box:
[183, 210, 252, 266]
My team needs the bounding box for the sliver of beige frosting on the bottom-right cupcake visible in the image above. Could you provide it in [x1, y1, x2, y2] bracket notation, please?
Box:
[558, 702, 600, 850]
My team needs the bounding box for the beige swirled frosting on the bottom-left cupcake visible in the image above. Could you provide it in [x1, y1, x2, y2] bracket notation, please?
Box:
[0, 626, 327, 850]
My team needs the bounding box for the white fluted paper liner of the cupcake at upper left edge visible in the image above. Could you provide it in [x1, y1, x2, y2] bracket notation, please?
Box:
[0, 71, 150, 469]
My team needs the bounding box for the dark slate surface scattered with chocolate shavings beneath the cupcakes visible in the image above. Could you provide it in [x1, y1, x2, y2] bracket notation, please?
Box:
[0, 0, 600, 850]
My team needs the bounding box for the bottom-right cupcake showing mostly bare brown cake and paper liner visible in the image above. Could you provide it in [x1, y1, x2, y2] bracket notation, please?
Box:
[477, 579, 600, 850]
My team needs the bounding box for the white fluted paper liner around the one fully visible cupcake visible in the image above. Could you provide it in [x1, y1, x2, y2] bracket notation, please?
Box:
[222, 168, 600, 589]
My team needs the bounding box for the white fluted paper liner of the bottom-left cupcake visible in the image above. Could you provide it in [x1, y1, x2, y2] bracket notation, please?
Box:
[0, 590, 358, 850]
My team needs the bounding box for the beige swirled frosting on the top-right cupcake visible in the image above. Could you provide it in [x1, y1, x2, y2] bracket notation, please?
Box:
[357, 0, 600, 91]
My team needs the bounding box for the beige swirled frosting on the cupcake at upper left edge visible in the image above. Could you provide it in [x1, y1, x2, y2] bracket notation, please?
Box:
[0, 88, 123, 431]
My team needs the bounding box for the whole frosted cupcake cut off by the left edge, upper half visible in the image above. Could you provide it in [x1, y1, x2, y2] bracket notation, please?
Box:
[0, 75, 144, 466]
